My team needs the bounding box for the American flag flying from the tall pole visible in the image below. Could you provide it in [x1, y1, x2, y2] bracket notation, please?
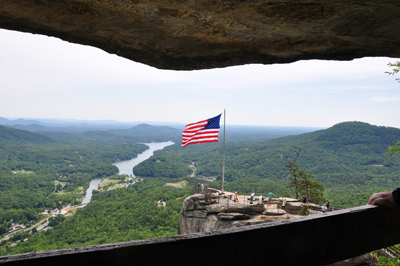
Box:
[181, 114, 221, 148]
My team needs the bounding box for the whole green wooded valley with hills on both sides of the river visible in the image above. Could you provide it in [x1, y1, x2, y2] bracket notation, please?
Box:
[0, 118, 400, 256]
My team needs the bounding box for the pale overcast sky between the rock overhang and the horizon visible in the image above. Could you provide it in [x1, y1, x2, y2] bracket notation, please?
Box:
[0, 29, 400, 128]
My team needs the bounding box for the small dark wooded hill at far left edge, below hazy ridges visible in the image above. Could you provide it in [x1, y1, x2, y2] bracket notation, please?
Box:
[0, 126, 55, 147]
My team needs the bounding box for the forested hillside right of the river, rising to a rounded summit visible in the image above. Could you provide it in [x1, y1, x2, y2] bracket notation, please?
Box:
[134, 122, 400, 207]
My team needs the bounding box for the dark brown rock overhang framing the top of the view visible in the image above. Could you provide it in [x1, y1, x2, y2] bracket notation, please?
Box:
[0, 0, 400, 70]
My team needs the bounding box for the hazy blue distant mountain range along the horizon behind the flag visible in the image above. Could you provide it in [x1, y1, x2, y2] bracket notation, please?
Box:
[0, 117, 321, 142]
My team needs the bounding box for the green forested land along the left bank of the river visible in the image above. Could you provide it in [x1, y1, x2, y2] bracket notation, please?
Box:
[0, 126, 148, 228]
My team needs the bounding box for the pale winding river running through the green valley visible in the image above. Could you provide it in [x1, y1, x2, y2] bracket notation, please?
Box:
[82, 141, 174, 205]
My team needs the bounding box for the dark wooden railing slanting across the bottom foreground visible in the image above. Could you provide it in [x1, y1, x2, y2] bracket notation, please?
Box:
[0, 205, 400, 266]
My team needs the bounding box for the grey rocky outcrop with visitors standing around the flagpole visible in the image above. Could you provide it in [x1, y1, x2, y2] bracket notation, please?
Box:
[178, 192, 304, 235]
